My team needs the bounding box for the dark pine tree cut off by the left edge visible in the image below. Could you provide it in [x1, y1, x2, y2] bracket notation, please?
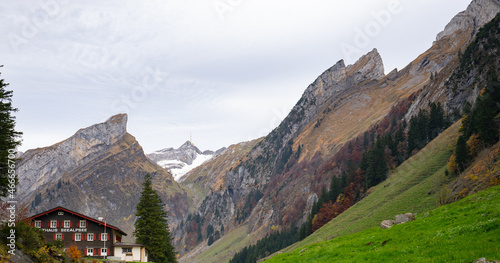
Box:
[0, 66, 22, 197]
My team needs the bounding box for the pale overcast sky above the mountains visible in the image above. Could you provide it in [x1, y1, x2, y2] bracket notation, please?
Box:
[0, 0, 470, 153]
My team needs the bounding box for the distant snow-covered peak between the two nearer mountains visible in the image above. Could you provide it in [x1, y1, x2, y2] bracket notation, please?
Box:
[146, 141, 225, 181]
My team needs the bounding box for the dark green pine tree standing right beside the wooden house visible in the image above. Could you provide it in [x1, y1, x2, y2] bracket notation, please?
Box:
[134, 174, 177, 263]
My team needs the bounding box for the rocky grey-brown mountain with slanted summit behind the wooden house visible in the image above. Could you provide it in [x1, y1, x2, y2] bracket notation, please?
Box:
[17, 114, 191, 241]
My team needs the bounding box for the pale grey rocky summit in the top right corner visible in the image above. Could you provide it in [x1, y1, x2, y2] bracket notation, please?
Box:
[436, 0, 500, 41]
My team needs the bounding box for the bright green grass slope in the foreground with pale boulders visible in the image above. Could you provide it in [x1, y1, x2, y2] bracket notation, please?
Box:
[266, 186, 500, 262]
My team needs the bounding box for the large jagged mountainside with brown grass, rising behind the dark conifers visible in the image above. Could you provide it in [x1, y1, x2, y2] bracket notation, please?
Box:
[181, 0, 500, 262]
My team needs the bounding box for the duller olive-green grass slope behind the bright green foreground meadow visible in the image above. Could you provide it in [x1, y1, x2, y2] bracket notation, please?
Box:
[270, 122, 460, 260]
